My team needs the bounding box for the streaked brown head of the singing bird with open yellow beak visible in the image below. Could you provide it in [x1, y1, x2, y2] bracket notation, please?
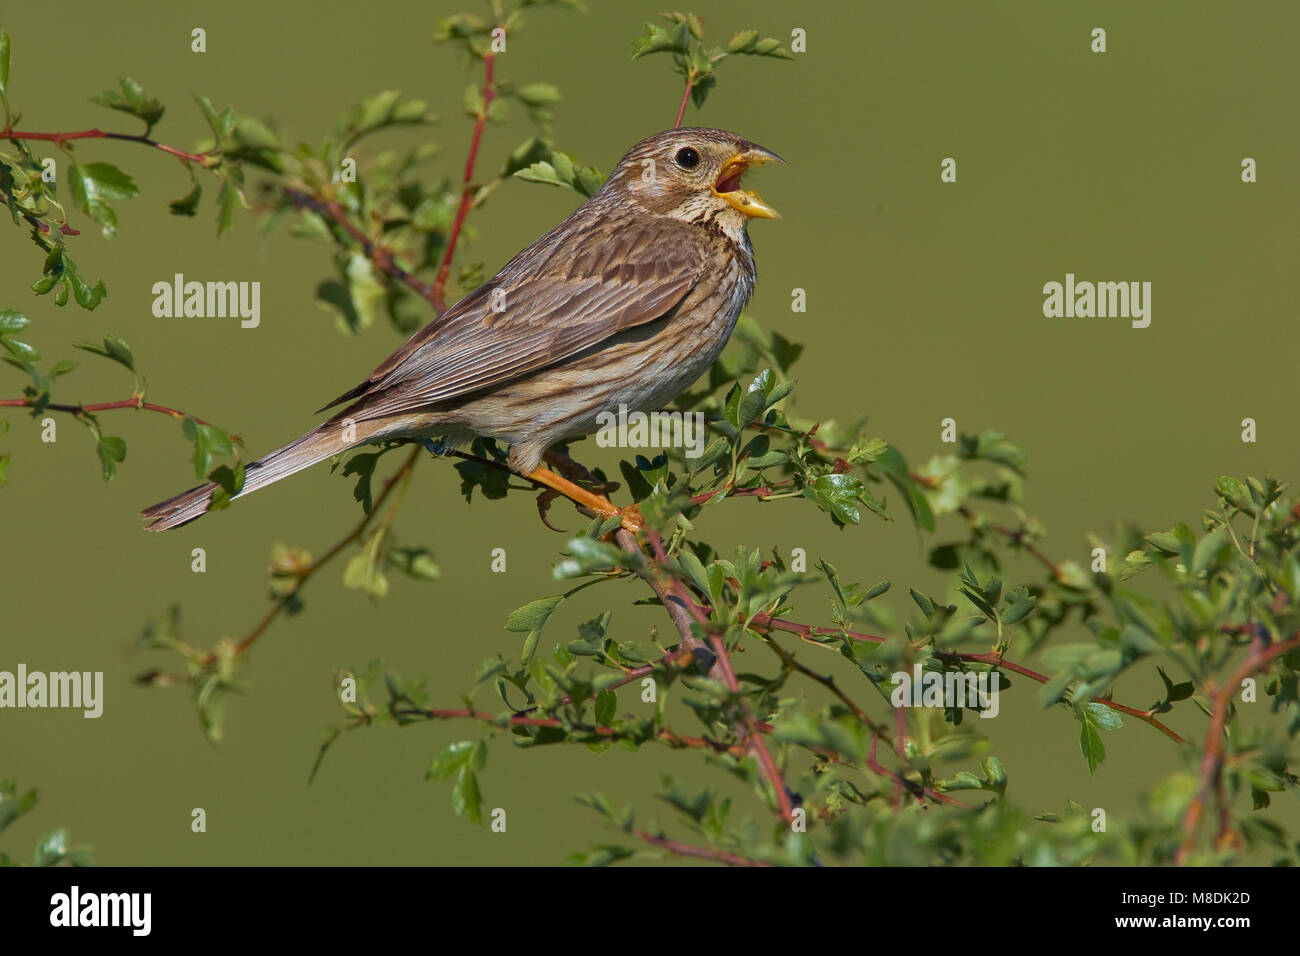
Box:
[606, 127, 785, 233]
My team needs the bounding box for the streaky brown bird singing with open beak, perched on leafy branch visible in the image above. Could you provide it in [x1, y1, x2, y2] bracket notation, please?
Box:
[142, 127, 784, 531]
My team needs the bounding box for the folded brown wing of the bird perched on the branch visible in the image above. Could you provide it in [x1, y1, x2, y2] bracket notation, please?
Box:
[315, 220, 706, 419]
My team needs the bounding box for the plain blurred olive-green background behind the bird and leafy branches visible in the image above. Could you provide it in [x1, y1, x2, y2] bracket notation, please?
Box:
[0, 0, 1300, 864]
